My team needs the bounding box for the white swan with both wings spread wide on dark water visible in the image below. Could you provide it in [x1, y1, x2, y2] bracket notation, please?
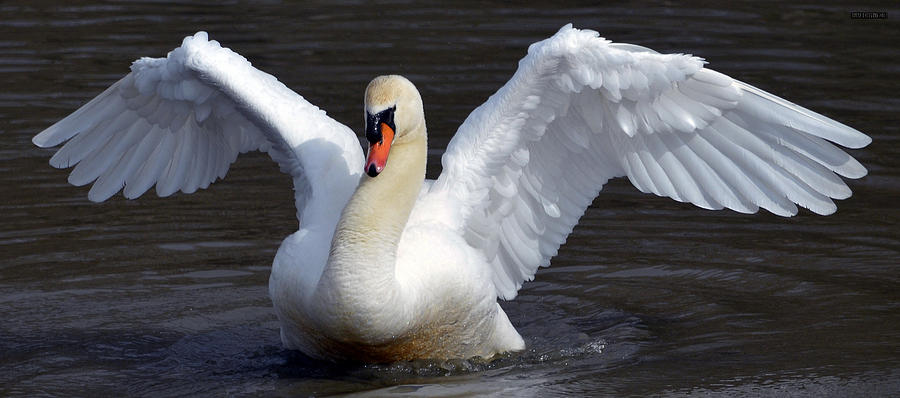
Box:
[33, 25, 871, 361]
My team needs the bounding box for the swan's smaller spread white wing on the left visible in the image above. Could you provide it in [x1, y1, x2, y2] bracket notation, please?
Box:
[33, 32, 363, 227]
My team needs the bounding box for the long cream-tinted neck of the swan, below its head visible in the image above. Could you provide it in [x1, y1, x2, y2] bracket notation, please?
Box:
[318, 129, 427, 301]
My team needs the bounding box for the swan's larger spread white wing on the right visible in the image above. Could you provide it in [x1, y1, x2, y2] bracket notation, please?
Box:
[433, 25, 871, 299]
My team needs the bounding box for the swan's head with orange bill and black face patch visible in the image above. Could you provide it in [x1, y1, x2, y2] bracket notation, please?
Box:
[365, 75, 425, 177]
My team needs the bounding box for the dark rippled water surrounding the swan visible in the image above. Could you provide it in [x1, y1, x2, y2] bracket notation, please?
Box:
[0, 1, 900, 396]
